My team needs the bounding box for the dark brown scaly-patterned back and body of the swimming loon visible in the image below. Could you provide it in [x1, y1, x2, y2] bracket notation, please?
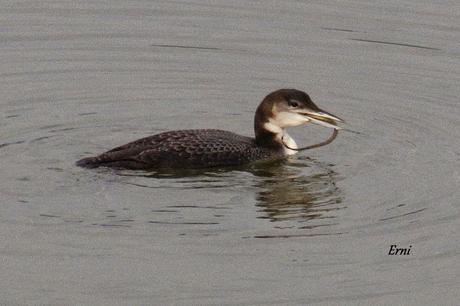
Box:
[77, 129, 282, 169]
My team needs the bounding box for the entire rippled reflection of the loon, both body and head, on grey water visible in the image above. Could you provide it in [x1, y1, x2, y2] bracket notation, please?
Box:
[118, 157, 343, 229]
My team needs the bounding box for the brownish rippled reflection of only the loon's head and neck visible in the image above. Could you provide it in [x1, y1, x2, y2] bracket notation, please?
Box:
[246, 158, 342, 228]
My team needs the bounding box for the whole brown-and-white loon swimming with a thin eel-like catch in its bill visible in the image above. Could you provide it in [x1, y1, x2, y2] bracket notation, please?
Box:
[76, 89, 343, 169]
